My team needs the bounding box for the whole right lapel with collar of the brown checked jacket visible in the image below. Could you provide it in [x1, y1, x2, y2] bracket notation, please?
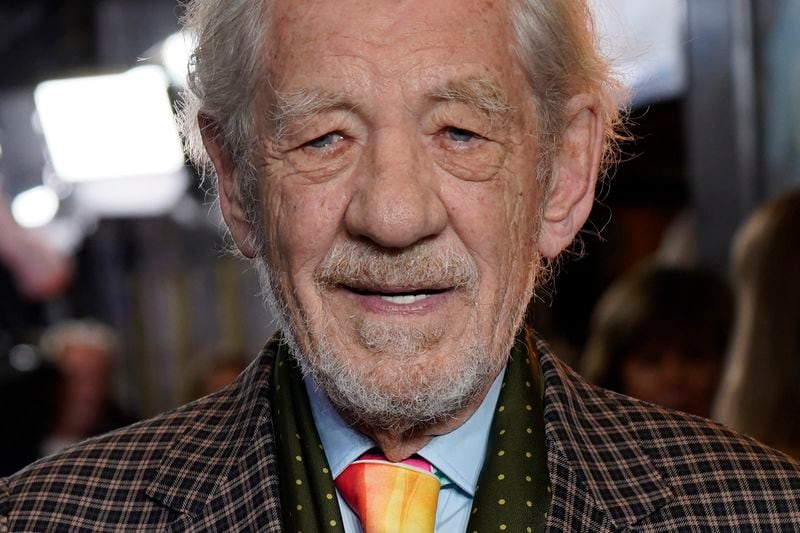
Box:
[536, 332, 673, 531]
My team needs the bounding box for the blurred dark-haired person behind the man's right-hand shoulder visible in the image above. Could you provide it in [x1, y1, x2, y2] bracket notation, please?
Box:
[582, 264, 733, 417]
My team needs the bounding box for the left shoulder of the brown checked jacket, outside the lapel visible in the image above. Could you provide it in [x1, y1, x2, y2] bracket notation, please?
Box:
[0, 384, 236, 531]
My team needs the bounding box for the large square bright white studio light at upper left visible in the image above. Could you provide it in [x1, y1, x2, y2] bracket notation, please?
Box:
[34, 66, 184, 182]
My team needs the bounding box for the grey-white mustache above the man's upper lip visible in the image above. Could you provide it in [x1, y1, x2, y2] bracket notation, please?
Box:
[314, 241, 478, 290]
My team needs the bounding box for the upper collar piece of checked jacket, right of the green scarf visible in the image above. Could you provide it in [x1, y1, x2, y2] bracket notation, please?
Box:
[536, 337, 673, 529]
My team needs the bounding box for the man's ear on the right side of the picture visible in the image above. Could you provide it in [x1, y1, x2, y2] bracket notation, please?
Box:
[538, 95, 604, 259]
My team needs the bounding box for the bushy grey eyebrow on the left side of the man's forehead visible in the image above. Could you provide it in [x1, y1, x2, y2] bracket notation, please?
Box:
[269, 89, 357, 141]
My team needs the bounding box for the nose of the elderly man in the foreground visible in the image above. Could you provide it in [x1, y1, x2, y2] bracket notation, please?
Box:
[345, 129, 447, 248]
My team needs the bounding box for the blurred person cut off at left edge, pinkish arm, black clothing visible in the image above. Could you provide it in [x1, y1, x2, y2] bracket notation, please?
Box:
[0, 188, 74, 475]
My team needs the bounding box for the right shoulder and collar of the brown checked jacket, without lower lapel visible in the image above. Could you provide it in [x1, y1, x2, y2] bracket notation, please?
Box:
[538, 340, 800, 531]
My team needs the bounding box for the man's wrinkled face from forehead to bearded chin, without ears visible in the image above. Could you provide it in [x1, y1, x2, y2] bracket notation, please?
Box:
[253, 0, 542, 430]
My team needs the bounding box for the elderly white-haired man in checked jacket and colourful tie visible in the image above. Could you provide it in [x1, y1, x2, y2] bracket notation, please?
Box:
[0, 0, 800, 532]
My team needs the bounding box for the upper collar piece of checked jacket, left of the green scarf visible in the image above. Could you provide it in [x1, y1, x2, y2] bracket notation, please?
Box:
[146, 338, 280, 516]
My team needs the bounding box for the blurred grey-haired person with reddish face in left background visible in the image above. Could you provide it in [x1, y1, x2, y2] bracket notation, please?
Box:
[40, 320, 135, 455]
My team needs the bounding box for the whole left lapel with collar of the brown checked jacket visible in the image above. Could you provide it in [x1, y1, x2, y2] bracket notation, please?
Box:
[146, 344, 278, 530]
